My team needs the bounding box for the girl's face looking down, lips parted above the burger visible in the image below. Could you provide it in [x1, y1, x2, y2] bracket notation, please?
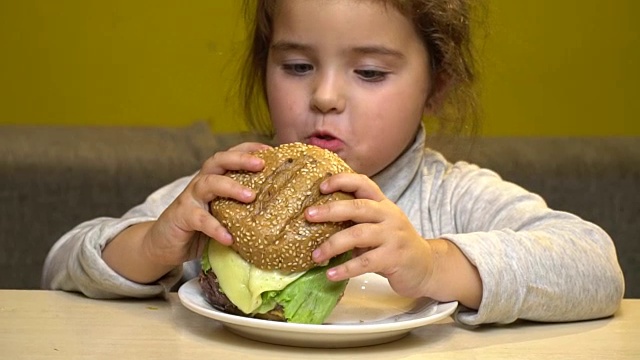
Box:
[266, 0, 431, 176]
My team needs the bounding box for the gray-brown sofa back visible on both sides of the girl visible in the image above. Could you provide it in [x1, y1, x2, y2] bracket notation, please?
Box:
[0, 123, 640, 298]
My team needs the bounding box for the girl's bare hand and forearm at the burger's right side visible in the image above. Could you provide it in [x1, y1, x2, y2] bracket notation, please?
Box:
[305, 174, 482, 309]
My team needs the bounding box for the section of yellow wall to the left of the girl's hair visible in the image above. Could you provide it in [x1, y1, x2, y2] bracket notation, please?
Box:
[0, 0, 248, 130]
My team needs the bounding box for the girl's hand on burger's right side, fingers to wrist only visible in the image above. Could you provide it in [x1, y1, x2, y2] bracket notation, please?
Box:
[305, 174, 433, 297]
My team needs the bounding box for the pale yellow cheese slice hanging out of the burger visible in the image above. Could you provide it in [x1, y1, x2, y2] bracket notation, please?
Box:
[208, 241, 305, 314]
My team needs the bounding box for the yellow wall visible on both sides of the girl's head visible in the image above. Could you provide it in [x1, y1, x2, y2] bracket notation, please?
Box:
[0, 0, 640, 135]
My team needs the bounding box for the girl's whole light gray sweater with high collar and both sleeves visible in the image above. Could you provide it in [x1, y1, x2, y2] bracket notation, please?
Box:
[43, 132, 624, 325]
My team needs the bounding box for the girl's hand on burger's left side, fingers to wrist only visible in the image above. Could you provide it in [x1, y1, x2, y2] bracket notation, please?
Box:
[143, 143, 269, 266]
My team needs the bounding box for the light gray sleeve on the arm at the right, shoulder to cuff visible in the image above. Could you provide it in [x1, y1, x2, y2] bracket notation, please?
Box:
[430, 163, 624, 325]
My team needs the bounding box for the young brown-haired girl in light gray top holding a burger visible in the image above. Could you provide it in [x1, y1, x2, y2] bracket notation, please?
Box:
[44, 0, 624, 325]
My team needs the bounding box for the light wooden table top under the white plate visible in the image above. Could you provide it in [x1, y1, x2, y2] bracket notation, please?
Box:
[0, 290, 640, 360]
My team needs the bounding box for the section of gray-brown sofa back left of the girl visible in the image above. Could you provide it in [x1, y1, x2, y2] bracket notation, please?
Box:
[0, 123, 260, 288]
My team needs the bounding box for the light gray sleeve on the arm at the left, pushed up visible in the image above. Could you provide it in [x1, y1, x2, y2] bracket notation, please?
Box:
[42, 177, 196, 298]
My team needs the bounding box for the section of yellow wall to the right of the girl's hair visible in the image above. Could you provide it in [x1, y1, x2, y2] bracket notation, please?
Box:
[483, 0, 640, 135]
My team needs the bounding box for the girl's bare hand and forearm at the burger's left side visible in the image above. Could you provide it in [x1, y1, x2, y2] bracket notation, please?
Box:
[102, 143, 269, 284]
